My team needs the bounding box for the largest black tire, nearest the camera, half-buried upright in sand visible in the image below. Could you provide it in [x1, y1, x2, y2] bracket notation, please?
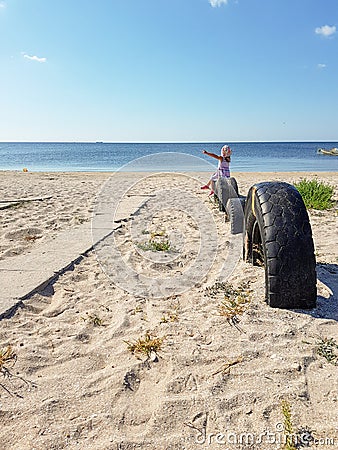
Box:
[243, 182, 317, 309]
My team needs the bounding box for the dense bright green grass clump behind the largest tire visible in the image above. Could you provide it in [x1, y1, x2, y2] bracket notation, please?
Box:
[295, 179, 334, 210]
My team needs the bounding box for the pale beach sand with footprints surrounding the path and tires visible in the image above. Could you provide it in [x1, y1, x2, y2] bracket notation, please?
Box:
[0, 172, 338, 450]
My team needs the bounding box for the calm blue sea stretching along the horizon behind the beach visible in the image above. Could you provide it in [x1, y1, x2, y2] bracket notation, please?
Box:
[0, 142, 338, 172]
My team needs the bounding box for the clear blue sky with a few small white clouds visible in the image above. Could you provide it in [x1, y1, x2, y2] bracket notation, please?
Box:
[0, 0, 338, 142]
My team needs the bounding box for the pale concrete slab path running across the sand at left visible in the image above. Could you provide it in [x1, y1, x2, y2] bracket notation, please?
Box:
[0, 195, 147, 319]
